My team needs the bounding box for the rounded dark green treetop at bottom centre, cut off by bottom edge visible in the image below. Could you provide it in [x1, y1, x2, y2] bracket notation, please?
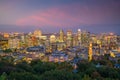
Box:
[41, 70, 81, 80]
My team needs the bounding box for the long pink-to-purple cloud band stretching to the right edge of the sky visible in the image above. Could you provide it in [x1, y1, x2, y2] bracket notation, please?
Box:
[16, 2, 120, 27]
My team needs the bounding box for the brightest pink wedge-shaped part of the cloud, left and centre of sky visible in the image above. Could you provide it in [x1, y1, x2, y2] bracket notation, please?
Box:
[16, 8, 79, 26]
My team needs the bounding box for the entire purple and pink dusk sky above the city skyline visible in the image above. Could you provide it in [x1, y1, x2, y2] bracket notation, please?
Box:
[0, 0, 120, 34]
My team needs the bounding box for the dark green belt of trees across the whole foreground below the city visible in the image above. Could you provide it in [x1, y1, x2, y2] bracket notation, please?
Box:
[0, 57, 120, 80]
